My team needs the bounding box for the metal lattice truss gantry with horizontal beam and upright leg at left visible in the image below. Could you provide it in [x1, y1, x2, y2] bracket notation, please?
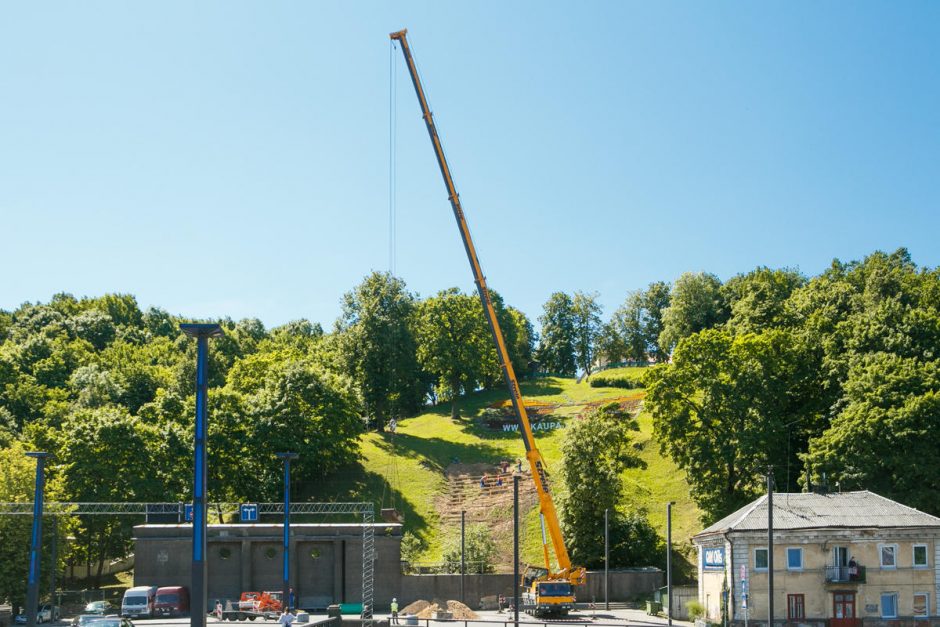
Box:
[0, 502, 375, 627]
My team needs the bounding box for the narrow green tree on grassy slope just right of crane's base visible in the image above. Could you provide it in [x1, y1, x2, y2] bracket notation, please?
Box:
[560, 403, 655, 568]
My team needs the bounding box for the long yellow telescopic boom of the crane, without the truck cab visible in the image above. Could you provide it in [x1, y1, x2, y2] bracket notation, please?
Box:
[389, 30, 584, 584]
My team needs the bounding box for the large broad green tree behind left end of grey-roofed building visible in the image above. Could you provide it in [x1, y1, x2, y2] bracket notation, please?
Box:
[644, 329, 821, 523]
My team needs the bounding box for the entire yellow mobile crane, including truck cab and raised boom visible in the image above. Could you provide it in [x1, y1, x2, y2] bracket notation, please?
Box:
[389, 30, 585, 615]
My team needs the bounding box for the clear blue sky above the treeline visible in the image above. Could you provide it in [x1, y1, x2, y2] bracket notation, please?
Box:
[0, 1, 940, 327]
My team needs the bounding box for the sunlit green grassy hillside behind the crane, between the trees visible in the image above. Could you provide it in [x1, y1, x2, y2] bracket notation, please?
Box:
[305, 368, 698, 562]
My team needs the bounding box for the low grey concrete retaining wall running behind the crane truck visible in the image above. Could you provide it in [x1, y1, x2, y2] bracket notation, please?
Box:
[398, 568, 665, 609]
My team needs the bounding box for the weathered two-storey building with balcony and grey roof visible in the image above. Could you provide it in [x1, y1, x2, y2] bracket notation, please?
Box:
[692, 491, 940, 627]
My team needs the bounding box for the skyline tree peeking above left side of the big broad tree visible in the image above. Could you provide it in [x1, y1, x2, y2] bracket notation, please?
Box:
[659, 272, 728, 351]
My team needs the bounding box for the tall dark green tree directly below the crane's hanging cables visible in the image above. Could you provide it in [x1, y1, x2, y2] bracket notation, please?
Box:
[336, 272, 428, 426]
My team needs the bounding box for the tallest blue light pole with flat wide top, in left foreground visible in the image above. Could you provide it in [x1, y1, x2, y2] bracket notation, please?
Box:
[180, 324, 222, 627]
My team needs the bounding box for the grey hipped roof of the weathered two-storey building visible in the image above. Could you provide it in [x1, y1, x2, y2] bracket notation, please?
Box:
[695, 490, 940, 537]
